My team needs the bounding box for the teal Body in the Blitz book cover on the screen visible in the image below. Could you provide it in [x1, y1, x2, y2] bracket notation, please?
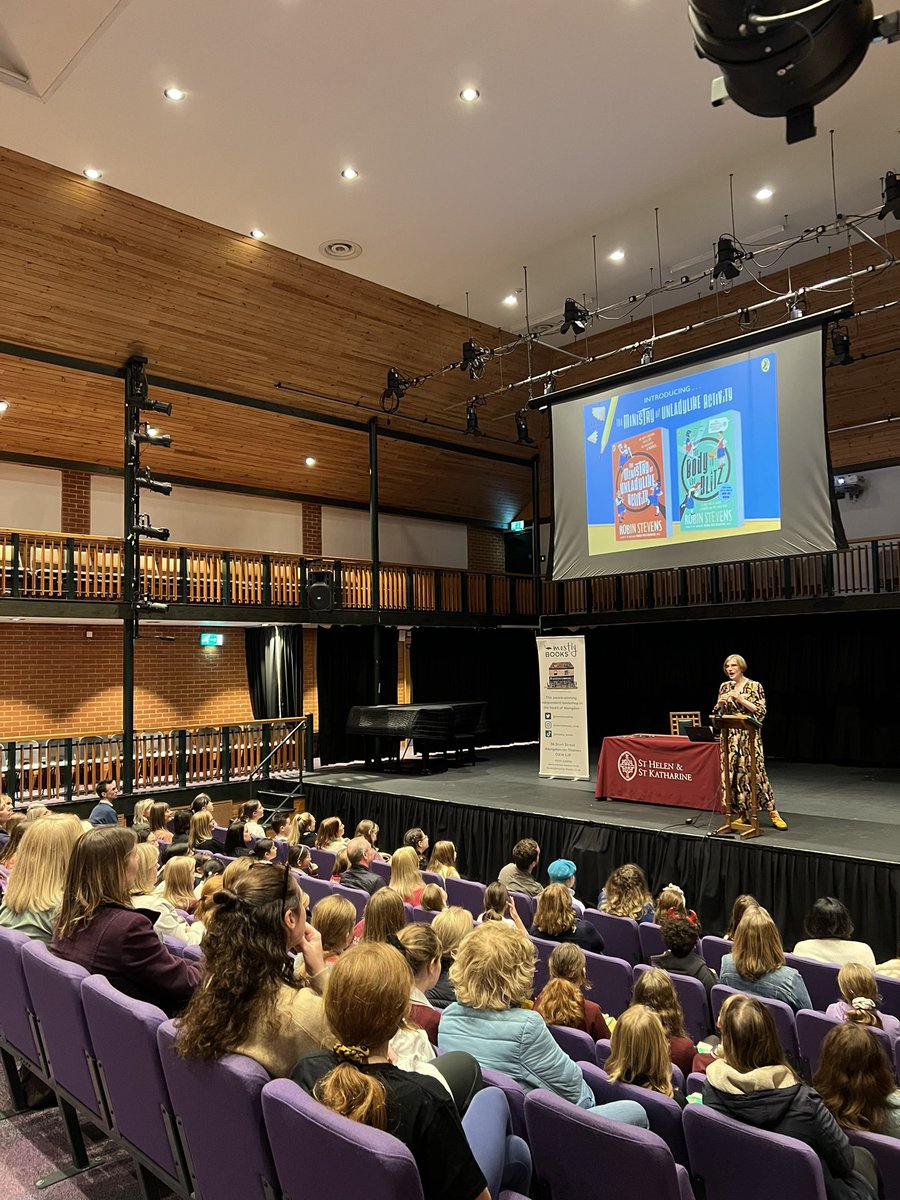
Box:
[676, 409, 744, 533]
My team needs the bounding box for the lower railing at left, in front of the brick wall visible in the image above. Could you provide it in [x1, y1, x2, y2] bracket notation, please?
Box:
[0, 718, 307, 803]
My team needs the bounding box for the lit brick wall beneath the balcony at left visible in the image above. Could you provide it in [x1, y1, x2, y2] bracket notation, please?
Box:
[0, 624, 252, 738]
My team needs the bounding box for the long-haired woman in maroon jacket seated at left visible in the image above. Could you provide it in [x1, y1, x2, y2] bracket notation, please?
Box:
[50, 826, 200, 1016]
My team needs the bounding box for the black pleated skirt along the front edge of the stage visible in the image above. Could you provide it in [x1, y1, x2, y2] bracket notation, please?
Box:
[306, 782, 900, 962]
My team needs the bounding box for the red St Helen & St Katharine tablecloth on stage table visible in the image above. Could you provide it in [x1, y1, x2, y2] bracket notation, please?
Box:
[594, 737, 720, 809]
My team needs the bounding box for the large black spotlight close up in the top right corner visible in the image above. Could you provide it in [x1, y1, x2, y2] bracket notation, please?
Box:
[688, 0, 900, 143]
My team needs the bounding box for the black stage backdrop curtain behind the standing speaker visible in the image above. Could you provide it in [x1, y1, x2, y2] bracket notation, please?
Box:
[586, 606, 900, 767]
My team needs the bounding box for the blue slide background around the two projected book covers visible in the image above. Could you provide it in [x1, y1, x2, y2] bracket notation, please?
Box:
[582, 352, 781, 528]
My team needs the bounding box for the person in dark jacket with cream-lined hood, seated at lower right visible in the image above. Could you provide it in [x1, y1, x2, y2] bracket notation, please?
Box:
[703, 993, 877, 1200]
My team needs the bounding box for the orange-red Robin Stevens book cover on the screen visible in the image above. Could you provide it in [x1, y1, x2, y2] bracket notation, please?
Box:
[612, 428, 672, 542]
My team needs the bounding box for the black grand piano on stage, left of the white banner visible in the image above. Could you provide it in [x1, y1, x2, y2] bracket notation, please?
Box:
[347, 700, 487, 775]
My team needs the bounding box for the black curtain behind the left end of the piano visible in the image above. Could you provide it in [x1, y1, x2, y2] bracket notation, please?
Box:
[316, 625, 397, 764]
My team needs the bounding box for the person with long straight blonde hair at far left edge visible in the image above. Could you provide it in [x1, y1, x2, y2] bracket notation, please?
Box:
[0, 812, 82, 946]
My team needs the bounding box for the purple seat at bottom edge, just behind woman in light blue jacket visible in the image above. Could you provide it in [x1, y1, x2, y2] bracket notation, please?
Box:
[526, 1091, 696, 1200]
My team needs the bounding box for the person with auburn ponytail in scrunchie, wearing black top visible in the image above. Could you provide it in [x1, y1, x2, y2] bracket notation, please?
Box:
[292, 943, 491, 1200]
